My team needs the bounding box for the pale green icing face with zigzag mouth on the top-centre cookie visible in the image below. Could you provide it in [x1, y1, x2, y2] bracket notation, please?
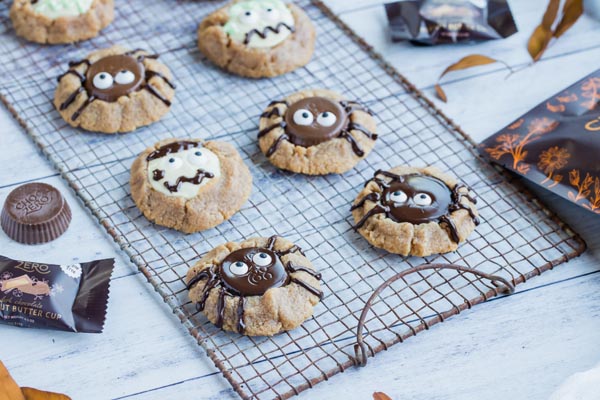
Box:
[223, 0, 294, 48]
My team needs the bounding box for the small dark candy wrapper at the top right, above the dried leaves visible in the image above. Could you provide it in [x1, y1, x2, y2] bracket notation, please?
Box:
[385, 0, 517, 45]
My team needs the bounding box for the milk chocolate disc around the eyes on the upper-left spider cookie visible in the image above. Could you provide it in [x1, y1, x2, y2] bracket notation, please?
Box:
[84, 54, 144, 102]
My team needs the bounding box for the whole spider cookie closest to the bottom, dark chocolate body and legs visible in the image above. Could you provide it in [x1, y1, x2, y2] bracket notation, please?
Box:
[186, 236, 323, 336]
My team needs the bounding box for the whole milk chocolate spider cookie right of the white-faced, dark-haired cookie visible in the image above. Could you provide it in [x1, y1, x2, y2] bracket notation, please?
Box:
[258, 90, 377, 175]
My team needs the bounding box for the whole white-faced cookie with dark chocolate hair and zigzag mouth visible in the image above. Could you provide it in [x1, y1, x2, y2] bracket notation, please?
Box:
[130, 139, 252, 233]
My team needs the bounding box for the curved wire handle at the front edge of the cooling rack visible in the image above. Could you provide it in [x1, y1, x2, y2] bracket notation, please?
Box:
[354, 264, 515, 367]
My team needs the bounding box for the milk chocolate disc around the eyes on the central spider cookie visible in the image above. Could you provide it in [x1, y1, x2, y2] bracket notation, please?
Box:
[285, 97, 348, 147]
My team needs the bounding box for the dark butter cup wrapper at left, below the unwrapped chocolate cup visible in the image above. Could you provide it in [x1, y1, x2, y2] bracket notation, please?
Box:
[0, 256, 114, 333]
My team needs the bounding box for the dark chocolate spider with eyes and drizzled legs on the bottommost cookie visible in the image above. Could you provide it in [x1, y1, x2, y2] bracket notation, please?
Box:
[187, 235, 323, 334]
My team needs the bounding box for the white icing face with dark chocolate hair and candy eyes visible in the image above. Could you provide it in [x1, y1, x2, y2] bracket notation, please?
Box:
[148, 142, 221, 199]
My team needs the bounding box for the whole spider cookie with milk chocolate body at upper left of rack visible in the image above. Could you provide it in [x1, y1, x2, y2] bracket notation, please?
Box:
[54, 46, 175, 133]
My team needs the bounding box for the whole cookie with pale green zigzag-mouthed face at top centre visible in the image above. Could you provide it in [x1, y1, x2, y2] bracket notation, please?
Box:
[198, 0, 315, 78]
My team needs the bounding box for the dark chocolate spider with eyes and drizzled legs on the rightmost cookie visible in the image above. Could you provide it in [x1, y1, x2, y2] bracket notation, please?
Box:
[350, 170, 479, 243]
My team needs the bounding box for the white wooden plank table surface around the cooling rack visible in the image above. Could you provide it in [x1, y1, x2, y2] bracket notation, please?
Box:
[0, 0, 600, 400]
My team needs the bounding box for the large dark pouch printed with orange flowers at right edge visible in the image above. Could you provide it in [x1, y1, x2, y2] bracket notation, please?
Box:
[479, 70, 600, 214]
